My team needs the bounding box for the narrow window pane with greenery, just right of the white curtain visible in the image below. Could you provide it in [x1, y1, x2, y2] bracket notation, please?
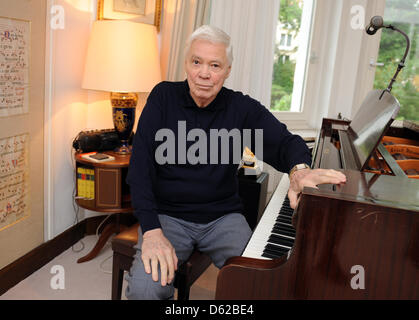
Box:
[271, 0, 313, 112]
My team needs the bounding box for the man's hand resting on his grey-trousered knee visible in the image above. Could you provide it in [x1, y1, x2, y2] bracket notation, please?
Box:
[141, 228, 178, 286]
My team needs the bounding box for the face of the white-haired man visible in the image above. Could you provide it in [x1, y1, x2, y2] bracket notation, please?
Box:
[185, 39, 231, 107]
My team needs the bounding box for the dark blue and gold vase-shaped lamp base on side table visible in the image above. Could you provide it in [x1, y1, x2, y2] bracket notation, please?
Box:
[111, 92, 138, 155]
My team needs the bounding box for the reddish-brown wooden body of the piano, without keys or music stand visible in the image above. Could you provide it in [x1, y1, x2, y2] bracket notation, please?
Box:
[216, 90, 419, 299]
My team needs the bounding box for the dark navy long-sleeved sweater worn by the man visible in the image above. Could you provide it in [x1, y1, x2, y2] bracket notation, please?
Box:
[127, 81, 311, 233]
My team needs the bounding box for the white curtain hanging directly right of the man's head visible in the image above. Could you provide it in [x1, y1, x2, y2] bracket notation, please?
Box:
[210, 0, 279, 107]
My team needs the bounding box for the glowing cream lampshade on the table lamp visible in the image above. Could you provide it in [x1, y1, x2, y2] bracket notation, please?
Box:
[82, 20, 161, 92]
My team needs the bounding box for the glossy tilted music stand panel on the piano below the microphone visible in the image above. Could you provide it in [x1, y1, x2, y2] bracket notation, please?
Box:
[348, 90, 400, 171]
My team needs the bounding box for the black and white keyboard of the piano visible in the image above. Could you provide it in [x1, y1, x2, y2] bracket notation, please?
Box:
[242, 174, 295, 259]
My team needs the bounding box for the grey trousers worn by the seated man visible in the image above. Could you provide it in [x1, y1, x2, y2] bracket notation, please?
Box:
[125, 213, 252, 300]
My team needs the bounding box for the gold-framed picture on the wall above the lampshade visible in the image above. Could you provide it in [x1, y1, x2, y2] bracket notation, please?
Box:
[97, 0, 162, 32]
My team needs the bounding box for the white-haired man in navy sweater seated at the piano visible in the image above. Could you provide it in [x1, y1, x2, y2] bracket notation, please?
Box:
[126, 26, 346, 299]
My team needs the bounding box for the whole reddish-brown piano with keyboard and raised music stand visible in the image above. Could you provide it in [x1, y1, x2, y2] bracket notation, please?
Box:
[215, 90, 419, 300]
